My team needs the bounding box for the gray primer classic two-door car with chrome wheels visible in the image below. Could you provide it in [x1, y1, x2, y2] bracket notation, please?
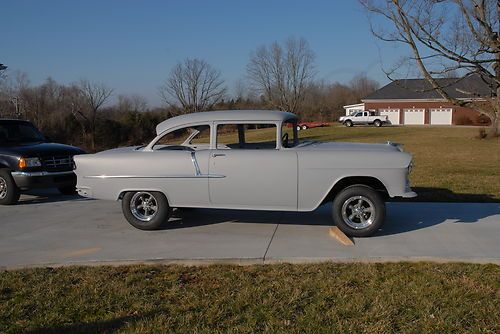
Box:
[75, 110, 416, 236]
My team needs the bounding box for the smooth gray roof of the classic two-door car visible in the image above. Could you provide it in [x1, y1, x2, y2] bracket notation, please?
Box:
[156, 110, 297, 135]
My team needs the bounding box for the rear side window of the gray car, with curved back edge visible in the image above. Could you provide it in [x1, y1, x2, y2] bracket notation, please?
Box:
[153, 125, 210, 150]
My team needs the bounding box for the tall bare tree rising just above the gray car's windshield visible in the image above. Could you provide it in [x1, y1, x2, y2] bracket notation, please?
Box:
[247, 38, 314, 112]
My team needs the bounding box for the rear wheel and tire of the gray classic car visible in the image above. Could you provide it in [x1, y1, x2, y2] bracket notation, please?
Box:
[122, 191, 170, 230]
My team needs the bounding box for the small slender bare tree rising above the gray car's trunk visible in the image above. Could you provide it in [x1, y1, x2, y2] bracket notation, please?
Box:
[77, 80, 113, 150]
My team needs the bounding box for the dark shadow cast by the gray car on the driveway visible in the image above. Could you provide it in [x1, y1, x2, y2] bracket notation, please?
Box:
[163, 202, 500, 236]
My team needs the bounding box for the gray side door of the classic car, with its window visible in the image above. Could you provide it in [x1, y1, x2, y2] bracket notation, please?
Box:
[209, 124, 297, 210]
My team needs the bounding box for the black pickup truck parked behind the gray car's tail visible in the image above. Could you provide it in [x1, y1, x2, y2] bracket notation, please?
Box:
[0, 119, 85, 205]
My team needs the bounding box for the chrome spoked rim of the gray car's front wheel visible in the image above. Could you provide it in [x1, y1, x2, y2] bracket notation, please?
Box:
[342, 196, 376, 230]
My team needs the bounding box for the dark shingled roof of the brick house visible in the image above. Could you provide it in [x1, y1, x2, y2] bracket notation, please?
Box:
[362, 75, 492, 101]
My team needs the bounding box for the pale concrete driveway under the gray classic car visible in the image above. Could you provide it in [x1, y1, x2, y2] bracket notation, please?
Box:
[0, 191, 500, 268]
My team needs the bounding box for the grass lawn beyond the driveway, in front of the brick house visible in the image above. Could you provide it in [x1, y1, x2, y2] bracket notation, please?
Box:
[244, 126, 500, 202]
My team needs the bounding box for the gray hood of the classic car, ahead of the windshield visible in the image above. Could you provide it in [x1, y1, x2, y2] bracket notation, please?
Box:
[297, 142, 402, 152]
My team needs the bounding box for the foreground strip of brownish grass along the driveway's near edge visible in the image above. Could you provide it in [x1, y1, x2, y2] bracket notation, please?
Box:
[0, 263, 500, 333]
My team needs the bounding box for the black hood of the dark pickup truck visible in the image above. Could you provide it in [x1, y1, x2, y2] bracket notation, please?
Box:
[0, 143, 85, 157]
